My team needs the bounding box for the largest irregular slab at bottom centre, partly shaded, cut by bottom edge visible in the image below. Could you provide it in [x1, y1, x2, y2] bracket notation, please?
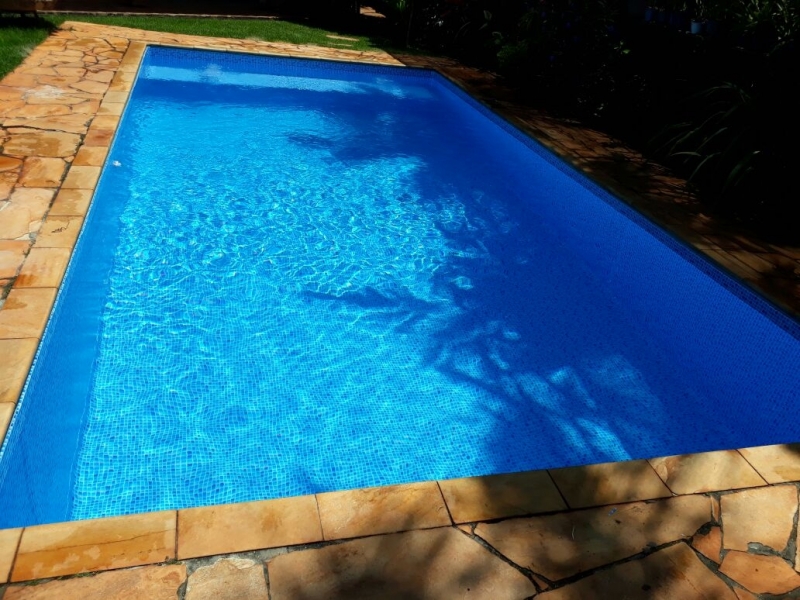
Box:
[267, 527, 536, 600]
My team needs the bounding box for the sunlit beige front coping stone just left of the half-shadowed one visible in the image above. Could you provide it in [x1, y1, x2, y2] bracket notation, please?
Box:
[317, 481, 450, 540]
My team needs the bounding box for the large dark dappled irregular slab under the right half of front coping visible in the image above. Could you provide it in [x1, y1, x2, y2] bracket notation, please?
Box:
[475, 496, 711, 581]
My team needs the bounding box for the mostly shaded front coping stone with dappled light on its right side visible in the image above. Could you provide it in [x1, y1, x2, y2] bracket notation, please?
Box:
[550, 460, 672, 508]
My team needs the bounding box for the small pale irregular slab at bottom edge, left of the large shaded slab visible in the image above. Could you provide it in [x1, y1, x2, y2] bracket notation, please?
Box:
[186, 558, 269, 600]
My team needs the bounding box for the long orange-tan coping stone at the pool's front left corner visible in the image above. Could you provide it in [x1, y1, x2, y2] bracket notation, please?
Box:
[11, 511, 176, 581]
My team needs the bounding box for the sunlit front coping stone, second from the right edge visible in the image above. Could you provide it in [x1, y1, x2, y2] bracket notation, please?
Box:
[649, 450, 766, 494]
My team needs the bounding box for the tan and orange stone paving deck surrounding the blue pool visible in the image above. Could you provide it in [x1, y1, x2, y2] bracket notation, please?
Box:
[0, 23, 800, 600]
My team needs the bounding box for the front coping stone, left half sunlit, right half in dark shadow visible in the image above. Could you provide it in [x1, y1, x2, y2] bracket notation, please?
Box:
[439, 471, 567, 523]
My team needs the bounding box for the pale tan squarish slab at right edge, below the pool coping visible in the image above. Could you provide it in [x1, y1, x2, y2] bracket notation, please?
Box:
[721, 485, 797, 552]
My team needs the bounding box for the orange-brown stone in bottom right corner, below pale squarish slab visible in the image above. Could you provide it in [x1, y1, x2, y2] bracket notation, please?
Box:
[719, 550, 800, 594]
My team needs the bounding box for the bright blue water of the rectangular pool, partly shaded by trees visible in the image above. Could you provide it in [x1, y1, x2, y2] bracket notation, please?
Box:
[0, 48, 800, 527]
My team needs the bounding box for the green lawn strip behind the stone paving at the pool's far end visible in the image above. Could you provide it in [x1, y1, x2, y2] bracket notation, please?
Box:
[0, 15, 400, 77]
